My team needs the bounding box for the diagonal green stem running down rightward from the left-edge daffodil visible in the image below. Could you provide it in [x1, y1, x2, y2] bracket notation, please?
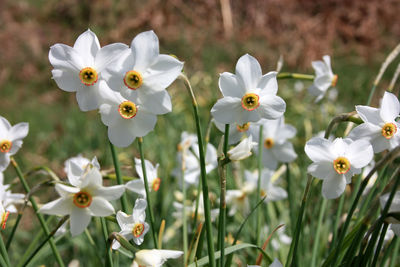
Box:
[11, 157, 64, 267]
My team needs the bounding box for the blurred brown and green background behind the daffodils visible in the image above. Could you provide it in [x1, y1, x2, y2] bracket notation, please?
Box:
[0, 0, 400, 266]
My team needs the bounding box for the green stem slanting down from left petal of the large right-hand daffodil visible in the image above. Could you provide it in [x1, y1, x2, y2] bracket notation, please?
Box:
[285, 175, 313, 267]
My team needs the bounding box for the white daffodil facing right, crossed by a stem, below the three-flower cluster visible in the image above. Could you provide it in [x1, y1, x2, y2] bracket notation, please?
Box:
[125, 158, 161, 197]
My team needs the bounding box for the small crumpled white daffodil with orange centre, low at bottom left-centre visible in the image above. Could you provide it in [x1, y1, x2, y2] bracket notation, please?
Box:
[112, 198, 149, 249]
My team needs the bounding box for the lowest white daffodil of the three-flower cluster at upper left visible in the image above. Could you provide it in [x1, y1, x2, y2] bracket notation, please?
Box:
[99, 81, 157, 147]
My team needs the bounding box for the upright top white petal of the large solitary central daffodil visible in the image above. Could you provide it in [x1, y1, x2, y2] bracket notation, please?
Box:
[236, 54, 262, 91]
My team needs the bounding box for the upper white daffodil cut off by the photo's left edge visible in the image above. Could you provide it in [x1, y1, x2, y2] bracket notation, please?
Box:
[0, 116, 29, 172]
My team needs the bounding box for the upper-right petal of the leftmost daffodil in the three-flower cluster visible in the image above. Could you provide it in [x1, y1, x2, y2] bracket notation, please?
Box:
[94, 43, 129, 72]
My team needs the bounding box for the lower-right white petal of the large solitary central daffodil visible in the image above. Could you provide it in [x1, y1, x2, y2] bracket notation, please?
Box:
[256, 95, 286, 120]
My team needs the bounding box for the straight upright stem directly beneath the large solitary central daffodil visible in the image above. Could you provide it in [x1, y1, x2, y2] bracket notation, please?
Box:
[217, 124, 229, 267]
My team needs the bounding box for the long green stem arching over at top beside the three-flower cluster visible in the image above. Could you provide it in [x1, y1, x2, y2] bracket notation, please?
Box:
[179, 73, 215, 267]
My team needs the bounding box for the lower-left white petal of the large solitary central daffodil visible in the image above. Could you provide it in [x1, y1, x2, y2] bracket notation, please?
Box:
[211, 97, 243, 124]
